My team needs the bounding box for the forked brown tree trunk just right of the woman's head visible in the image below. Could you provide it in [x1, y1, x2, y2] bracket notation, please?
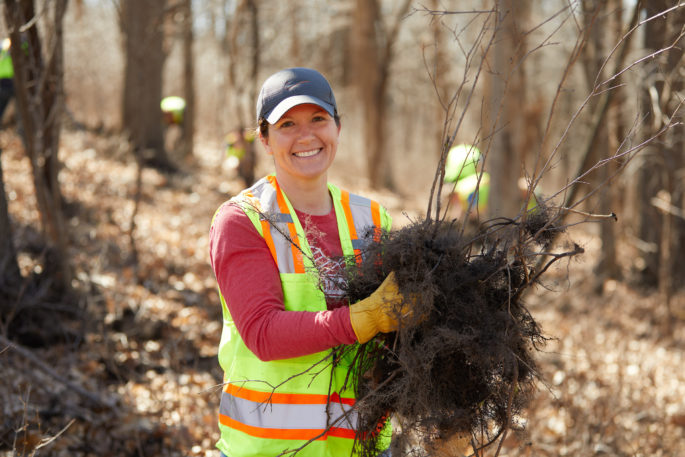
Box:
[353, 0, 411, 189]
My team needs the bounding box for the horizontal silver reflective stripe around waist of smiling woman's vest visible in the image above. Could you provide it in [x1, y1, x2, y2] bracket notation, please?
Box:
[219, 392, 357, 431]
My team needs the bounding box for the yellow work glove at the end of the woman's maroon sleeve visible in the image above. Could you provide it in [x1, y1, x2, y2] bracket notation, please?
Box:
[350, 272, 410, 343]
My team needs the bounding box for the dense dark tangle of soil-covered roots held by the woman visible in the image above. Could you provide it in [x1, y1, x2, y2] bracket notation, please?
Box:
[345, 220, 546, 456]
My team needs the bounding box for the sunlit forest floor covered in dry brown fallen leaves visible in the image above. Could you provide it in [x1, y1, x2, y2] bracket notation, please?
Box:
[0, 131, 685, 457]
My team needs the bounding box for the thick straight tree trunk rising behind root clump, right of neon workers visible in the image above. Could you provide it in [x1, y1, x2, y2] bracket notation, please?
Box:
[485, 0, 530, 217]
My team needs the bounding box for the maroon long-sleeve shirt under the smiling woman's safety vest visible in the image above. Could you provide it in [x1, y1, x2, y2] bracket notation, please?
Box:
[209, 204, 356, 361]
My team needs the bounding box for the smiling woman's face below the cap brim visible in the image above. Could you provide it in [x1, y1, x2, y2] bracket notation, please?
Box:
[261, 104, 340, 183]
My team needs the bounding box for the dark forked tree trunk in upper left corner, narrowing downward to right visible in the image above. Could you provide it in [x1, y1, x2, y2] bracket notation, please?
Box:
[5, 0, 71, 288]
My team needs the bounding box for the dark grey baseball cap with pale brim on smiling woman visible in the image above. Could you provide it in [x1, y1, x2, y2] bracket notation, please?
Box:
[257, 67, 338, 124]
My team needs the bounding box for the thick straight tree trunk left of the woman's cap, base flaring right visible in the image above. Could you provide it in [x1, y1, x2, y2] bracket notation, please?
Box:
[120, 0, 170, 170]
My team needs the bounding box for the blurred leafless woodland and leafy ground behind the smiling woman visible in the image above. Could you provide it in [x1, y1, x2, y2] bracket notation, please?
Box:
[0, 0, 685, 457]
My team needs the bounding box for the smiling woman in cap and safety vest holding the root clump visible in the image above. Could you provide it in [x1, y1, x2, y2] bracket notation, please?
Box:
[209, 68, 402, 457]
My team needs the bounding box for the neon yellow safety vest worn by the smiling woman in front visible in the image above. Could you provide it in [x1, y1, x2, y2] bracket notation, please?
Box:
[211, 175, 391, 457]
